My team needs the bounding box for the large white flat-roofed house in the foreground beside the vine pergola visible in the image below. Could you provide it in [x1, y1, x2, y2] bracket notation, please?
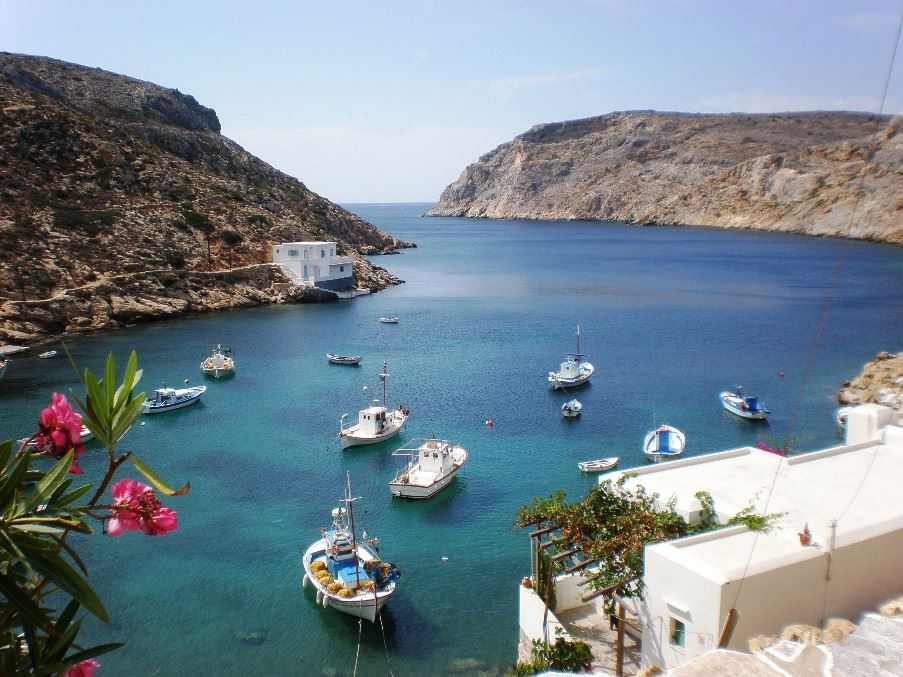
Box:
[520, 405, 903, 669]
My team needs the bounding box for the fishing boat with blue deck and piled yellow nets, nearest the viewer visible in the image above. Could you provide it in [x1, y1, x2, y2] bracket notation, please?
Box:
[301, 477, 401, 623]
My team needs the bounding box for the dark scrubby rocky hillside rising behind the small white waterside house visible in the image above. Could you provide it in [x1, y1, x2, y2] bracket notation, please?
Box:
[0, 53, 409, 312]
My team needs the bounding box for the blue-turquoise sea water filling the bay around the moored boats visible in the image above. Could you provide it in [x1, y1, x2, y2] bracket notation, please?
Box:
[0, 205, 903, 675]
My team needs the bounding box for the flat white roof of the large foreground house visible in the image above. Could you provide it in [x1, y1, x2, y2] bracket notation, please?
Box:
[600, 405, 903, 583]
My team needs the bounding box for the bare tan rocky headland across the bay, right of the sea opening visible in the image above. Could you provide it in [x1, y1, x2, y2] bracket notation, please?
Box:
[428, 107, 903, 244]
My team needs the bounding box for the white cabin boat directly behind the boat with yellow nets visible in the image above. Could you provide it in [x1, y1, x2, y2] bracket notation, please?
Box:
[389, 437, 468, 498]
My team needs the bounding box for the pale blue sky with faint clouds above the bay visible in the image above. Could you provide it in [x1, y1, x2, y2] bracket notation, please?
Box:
[0, 0, 903, 203]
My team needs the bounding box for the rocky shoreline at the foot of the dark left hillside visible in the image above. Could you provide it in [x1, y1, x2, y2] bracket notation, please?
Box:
[0, 257, 402, 345]
